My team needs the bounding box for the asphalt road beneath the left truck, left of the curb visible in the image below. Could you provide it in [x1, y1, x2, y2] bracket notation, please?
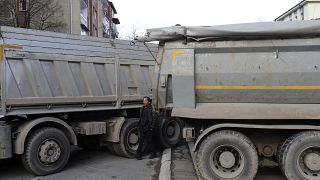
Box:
[0, 149, 160, 180]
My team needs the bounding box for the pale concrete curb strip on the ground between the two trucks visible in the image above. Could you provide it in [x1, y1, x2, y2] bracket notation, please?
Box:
[159, 148, 171, 180]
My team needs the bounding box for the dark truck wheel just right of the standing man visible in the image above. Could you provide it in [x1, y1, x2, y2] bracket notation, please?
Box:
[158, 119, 183, 148]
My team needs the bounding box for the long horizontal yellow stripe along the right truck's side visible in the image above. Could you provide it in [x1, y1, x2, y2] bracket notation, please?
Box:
[195, 85, 320, 90]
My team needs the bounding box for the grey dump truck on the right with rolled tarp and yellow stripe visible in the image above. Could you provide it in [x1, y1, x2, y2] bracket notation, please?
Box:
[137, 20, 320, 180]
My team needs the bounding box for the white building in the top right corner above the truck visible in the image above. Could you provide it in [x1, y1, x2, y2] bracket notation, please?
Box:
[275, 0, 320, 21]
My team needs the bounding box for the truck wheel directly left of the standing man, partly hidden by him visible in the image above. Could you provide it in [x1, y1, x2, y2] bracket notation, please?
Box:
[109, 119, 139, 158]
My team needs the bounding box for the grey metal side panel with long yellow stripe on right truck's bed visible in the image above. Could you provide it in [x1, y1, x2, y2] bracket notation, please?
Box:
[195, 38, 320, 104]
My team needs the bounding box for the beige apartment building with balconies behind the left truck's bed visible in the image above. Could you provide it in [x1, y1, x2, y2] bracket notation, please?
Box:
[64, 0, 120, 38]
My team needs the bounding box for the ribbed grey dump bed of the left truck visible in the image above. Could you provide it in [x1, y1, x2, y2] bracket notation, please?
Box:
[0, 26, 158, 115]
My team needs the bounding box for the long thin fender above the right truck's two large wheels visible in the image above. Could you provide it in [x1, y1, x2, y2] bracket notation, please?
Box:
[193, 124, 320, 151]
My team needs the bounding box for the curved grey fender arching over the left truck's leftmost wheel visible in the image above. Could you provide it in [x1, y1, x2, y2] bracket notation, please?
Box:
[13, 117, 77, 154]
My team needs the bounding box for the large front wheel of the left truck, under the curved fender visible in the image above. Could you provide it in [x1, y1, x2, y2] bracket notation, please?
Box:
[22, 128, 70, 176]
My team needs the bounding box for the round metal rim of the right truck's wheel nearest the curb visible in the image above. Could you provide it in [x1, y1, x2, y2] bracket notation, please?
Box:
[210, 145, 244, 179]
